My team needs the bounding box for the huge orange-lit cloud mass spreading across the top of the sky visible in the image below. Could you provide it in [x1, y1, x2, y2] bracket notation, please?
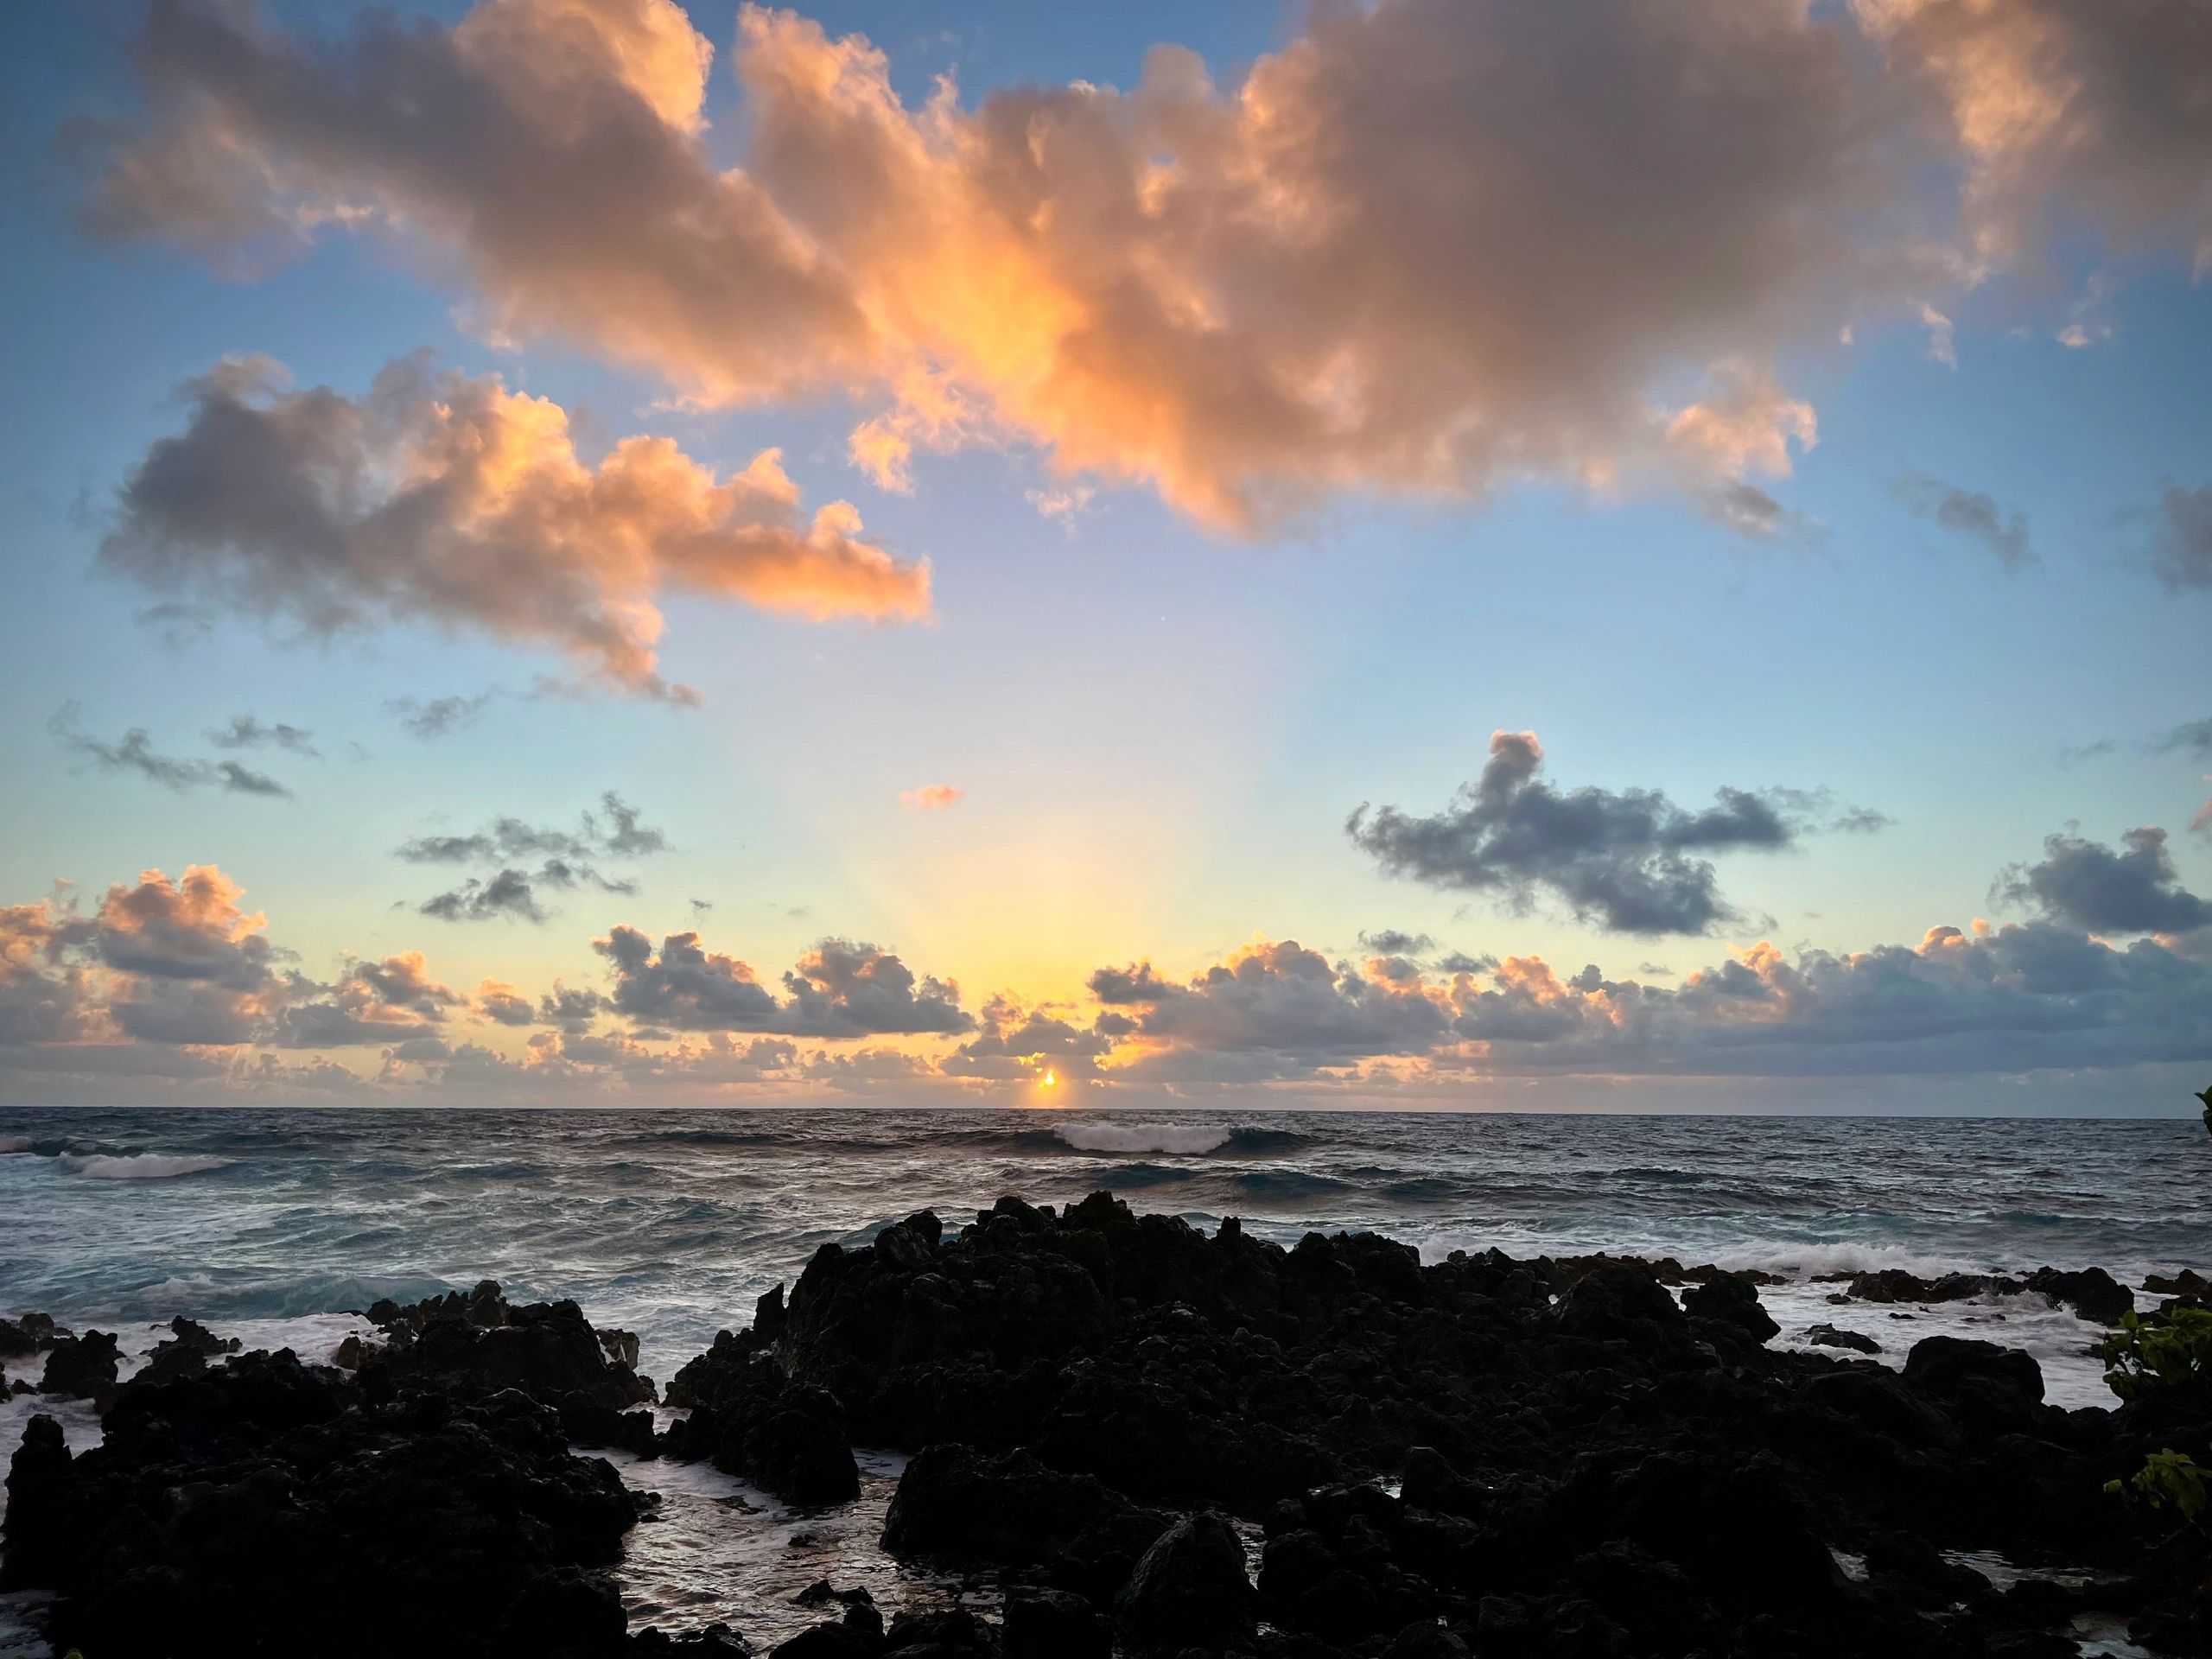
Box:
[107, 0, 2212, 535]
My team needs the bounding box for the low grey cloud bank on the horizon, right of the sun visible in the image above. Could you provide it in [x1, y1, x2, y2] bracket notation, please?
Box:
[1093, 923, 2212, 1090]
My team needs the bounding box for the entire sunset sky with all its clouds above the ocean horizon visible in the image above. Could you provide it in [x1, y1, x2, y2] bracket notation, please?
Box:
[0, 0, 2212, 1115]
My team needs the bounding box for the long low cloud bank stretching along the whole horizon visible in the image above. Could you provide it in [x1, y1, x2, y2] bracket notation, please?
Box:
[0, 804, 2212, 1103]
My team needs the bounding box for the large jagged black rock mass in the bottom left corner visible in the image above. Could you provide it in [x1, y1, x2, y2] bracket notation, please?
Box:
[26, 1351, 637, 1659]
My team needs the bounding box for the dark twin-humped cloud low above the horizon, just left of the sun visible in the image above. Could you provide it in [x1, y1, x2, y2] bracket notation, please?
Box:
[591, 927, 973, 1038]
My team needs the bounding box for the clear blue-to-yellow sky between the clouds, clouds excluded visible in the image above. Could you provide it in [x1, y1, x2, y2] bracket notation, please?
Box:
[0, 0, 2212, 1110]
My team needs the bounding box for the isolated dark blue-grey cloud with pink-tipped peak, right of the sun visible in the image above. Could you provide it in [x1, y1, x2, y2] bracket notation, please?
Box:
[1344, 732, 1880, 933]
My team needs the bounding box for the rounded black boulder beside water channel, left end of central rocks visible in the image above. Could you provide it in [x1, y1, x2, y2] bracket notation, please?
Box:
[666, 1332, 861, 1504]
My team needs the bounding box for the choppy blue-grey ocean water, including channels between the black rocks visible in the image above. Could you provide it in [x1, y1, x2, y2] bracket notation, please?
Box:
[0, 1109, 2212, 1656]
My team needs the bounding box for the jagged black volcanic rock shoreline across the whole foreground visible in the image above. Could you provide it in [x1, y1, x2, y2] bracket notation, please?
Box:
[0, 1192, 2212, 1659]
